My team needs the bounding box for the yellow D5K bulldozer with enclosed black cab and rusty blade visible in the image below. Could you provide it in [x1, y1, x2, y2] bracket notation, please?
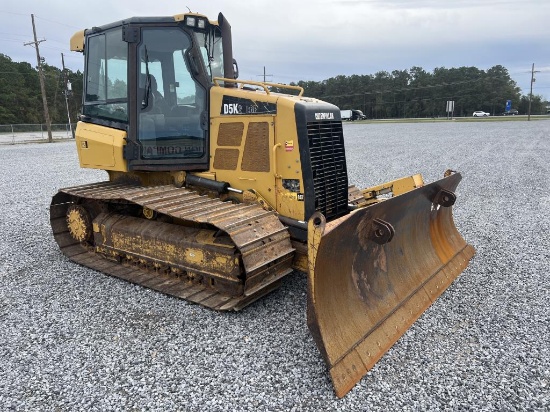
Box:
[50, 12, 475, 397]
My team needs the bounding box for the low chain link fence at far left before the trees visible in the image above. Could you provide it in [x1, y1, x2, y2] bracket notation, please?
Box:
[0, 123, 76, 144]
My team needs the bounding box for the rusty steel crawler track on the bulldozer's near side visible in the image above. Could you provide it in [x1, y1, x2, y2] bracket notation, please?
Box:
[50, 182, 294, 310]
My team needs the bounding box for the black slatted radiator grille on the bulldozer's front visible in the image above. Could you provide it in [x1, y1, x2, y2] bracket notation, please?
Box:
[307, 121, 348, 220]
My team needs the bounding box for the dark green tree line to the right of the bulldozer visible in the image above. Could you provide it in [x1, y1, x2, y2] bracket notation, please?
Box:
[296, 65, 547, 119]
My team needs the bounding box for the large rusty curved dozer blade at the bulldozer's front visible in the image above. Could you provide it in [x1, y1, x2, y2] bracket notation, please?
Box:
[307, 173, 475, 397]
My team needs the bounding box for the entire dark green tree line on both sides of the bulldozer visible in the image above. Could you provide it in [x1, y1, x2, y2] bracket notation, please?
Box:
[0, 53, 546, 124]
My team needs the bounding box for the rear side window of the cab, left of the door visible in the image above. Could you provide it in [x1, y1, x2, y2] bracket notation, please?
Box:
[83, 29, 128, 122]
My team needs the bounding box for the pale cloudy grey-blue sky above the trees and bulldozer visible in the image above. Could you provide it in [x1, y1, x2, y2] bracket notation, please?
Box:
[0, 0, 550, 100]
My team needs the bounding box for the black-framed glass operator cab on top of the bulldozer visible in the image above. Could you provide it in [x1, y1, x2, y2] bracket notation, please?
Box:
[81, 14, 229, 170]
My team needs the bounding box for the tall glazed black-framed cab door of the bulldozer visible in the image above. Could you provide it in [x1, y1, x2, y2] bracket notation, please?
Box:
[126, 25, 209, 170]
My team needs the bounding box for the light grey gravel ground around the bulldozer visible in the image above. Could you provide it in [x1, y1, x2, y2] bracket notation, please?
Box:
[0, 121, 550, 411]
